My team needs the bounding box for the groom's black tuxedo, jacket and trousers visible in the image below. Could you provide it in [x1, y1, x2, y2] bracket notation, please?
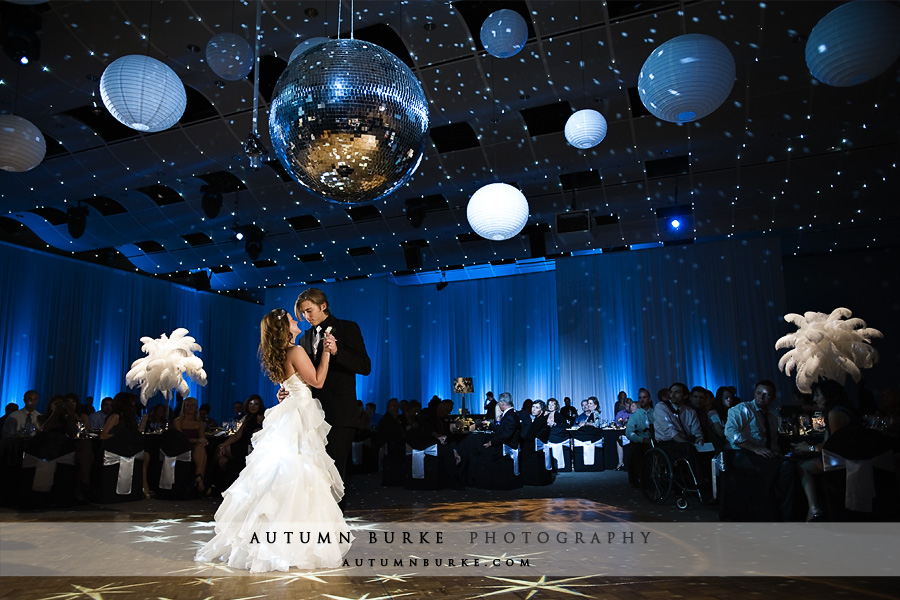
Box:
[297, 315, 372, 477]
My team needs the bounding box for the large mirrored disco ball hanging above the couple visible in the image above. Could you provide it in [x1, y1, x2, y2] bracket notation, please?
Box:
[269, 39, 428, 204]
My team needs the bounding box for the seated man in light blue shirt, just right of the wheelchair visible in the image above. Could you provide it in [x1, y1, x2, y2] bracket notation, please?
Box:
[725, 380, 795, 521]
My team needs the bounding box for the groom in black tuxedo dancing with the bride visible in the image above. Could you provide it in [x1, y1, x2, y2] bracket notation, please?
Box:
[278, 288, 372, 479]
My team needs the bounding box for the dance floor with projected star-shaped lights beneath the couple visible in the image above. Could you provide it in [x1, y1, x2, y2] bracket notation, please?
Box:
[0, 471, 900, 600]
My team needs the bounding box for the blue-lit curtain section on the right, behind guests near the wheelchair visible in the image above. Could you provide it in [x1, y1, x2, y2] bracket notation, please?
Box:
[556, 239, 790, 416]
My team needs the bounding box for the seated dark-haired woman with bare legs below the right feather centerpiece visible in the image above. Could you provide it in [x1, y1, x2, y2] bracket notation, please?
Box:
[792, 379, 862, 521]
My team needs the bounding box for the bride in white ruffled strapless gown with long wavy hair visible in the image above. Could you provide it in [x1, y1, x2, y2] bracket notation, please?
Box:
[195, 308, 352, 573]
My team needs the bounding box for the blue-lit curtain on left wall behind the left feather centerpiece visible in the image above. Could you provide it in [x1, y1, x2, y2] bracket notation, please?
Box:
[0, 244, 263, 418]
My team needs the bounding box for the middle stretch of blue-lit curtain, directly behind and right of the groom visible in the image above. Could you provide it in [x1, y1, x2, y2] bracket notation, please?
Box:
[266, 272, 559, 412]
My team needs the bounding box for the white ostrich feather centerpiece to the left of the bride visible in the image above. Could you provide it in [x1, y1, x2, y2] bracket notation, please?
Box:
[125, 327, 206, 406]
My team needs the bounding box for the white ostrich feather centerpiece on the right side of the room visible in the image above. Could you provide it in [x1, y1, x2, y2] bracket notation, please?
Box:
[775, 308, 884, 394]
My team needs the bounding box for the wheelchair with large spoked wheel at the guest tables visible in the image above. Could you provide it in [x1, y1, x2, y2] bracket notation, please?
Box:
[639, 437, 706, 510]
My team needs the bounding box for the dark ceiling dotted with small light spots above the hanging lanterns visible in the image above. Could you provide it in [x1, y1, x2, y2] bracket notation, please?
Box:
[0, 0, 900, 294]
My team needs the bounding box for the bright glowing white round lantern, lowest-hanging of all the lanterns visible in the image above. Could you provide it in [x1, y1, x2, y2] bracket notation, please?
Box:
[466, 183, 528, 242]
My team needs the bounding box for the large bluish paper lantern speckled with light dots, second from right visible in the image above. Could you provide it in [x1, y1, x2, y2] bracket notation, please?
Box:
[638, 33, 735, 123]
